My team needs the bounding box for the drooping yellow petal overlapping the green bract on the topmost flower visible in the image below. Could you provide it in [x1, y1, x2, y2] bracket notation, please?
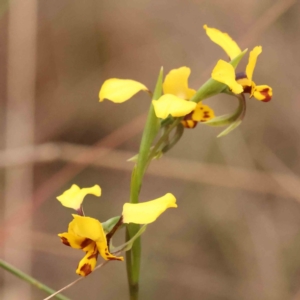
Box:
[211, 60, 243, 94]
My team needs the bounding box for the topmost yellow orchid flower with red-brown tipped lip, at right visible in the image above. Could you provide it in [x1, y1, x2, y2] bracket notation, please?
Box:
[203, 25, 273, 102]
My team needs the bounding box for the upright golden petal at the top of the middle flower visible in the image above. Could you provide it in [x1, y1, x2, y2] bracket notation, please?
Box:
[163, 67, 196, 100]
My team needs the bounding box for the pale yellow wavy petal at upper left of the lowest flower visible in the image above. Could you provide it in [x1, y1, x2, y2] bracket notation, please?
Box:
[56, 184, 101, 210]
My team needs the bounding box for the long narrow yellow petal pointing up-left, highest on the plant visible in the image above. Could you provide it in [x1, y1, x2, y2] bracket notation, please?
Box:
[203, 25, 242, 60]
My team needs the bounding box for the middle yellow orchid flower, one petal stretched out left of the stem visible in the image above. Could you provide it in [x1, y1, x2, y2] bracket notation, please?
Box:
[99, 67, 214, 127]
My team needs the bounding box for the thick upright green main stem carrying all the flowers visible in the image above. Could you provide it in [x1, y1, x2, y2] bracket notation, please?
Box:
[126, 69, 163, 300]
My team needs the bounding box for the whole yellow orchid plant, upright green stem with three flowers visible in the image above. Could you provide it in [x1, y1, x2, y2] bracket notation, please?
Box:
[57, 25, 272, 299]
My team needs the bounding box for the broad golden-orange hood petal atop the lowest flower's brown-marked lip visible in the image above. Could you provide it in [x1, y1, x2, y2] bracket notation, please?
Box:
[68, 215, 106, 242]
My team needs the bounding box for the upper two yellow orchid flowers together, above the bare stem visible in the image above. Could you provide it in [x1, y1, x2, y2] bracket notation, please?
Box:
[99, 25, 273, 135]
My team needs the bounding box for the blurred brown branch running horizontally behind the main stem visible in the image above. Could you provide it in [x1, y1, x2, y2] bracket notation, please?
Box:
[0, 143, 300, 202]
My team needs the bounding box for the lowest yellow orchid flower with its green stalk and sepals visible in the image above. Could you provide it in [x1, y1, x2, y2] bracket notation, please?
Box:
[57, 184, 177, 276]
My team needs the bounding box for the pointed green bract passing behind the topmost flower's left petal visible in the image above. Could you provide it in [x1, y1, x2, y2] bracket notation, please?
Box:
[190, 49, 248, 103]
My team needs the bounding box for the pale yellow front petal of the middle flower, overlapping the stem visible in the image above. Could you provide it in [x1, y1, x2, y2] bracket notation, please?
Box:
[152, 94, 197, 119]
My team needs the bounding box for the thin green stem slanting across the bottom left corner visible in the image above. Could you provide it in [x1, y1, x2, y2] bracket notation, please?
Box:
[0, 259, 70, 300]
